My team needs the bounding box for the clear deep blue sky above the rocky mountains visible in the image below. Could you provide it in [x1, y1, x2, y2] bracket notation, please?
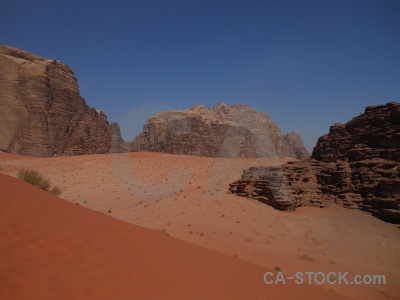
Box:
[0, 0, 400, 151]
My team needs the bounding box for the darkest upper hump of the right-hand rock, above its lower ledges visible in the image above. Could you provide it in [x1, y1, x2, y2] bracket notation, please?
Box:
[312, 102, 400, 162]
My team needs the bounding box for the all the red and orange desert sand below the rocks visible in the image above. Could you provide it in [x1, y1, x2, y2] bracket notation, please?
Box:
[0, 153, 400, 299]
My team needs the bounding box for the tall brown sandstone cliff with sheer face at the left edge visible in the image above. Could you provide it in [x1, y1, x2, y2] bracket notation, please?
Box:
[0, 45, 123, 157]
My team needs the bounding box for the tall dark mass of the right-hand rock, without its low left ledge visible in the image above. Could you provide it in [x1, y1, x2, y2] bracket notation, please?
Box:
[312, 102, 400, 223]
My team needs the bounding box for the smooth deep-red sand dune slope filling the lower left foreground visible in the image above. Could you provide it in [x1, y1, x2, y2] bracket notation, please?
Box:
[0, 174, 350, 300]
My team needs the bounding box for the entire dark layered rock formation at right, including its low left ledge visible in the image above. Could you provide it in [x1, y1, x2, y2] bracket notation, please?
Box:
[229, 102, 400, 223]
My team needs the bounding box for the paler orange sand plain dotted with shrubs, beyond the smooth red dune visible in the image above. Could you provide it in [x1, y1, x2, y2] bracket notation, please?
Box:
[0, 152, 400, 300]
